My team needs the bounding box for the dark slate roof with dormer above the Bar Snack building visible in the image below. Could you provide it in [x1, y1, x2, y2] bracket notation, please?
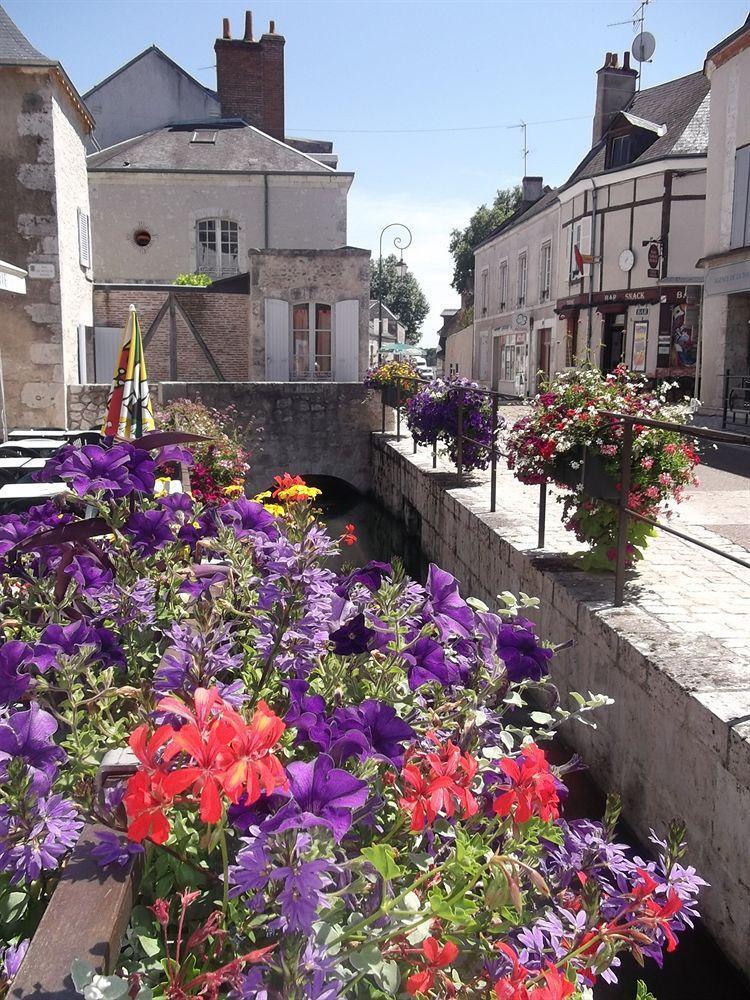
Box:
[564, 70, 709, 187]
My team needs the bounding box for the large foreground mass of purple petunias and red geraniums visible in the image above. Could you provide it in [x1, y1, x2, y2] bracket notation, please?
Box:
[0, 441, 701, 1000]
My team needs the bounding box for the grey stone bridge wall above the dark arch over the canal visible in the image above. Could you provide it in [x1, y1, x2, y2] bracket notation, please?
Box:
[159, 382, 381, 494]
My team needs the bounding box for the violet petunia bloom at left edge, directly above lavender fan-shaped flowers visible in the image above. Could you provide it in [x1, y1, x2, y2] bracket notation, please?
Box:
[0, 702, 65, 795]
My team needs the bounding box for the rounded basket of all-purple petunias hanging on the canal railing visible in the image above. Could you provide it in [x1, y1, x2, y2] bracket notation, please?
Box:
[406, 375, 505, 472]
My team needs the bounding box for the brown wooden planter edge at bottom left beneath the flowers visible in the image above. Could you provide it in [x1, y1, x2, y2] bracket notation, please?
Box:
[8, 823, 141, 1000]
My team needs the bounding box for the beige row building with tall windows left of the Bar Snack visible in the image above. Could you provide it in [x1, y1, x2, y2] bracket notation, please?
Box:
[472, 177, 560, 396]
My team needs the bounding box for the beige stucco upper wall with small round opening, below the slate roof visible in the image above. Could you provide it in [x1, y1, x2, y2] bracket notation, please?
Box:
[89, 170, 351, 282]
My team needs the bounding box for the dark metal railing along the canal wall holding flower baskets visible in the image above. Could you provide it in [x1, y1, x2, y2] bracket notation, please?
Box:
[382, 378, 750, 607]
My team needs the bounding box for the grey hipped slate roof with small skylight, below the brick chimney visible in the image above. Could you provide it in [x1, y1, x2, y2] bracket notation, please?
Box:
[87, 118, 348, 177]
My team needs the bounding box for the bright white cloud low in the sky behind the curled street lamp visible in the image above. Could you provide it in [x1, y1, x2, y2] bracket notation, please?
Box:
[348, 184, 476, 347]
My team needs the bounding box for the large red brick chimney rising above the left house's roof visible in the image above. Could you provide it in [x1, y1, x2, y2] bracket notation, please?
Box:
[219, 11, 284, 141]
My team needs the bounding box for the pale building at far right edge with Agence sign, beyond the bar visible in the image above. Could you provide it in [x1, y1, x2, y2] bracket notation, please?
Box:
[700, 17, 750, 411]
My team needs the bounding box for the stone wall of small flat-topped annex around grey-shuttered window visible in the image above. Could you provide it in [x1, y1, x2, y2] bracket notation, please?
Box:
[249, 247, 370, 381]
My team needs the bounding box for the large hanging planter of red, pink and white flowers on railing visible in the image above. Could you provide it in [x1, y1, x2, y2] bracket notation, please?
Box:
[507, 365, 699, 569]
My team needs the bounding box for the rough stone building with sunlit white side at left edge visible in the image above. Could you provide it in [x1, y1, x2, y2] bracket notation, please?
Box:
[0, 8, 94, 427]
